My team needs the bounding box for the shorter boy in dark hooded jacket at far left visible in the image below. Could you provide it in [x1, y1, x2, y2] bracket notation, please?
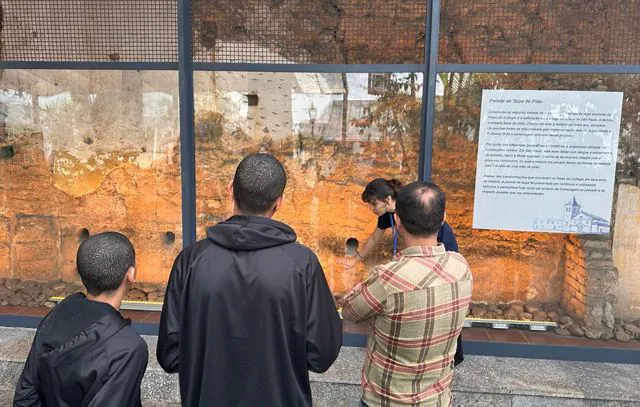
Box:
[13, 232, 149, 407]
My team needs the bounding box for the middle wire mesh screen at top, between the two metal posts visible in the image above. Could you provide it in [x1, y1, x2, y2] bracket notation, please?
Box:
[192, 0, 426, 64]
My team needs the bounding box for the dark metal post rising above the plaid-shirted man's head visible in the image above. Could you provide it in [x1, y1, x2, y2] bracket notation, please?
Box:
[418, 0, 440, 181]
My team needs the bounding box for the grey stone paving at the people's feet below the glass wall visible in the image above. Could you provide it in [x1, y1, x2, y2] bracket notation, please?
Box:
[0, 327, 640, 407]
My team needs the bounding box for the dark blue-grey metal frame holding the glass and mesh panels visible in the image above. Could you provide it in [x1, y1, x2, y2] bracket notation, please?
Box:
[0, 0, 640, 363]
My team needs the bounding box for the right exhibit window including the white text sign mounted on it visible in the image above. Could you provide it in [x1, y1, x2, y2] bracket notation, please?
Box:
[432, 73, 640, 340]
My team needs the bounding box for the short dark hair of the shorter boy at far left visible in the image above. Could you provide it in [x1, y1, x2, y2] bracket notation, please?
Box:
[76, 232, 136, 295]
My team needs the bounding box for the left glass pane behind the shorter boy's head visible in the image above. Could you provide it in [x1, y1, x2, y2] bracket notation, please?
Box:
[0, 70, 182, 299]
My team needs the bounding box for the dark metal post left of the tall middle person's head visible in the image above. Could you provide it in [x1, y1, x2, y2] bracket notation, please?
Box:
[178, 0, 196, 247]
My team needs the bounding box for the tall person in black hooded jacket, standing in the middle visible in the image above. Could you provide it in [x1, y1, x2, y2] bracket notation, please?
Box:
[157, 154, 342, 407]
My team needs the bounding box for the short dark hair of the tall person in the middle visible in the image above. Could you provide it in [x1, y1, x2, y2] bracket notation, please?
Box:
[233, 153, 287, 215]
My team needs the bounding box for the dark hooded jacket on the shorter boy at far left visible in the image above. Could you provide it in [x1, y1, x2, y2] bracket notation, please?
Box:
[13, 293, 148, 407]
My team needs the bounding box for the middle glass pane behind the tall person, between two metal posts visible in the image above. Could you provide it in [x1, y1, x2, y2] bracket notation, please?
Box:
[195, 72, 422, 292]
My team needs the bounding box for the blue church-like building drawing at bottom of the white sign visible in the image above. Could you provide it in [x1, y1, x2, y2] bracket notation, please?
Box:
[533, 196, 611, 234]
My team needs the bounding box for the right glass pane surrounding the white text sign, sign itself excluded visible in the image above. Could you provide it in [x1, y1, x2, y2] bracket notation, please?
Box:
[433, 73, 640, 339]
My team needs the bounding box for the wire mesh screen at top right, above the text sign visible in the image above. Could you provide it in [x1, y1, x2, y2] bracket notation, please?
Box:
[439, 0, 640, 64]
